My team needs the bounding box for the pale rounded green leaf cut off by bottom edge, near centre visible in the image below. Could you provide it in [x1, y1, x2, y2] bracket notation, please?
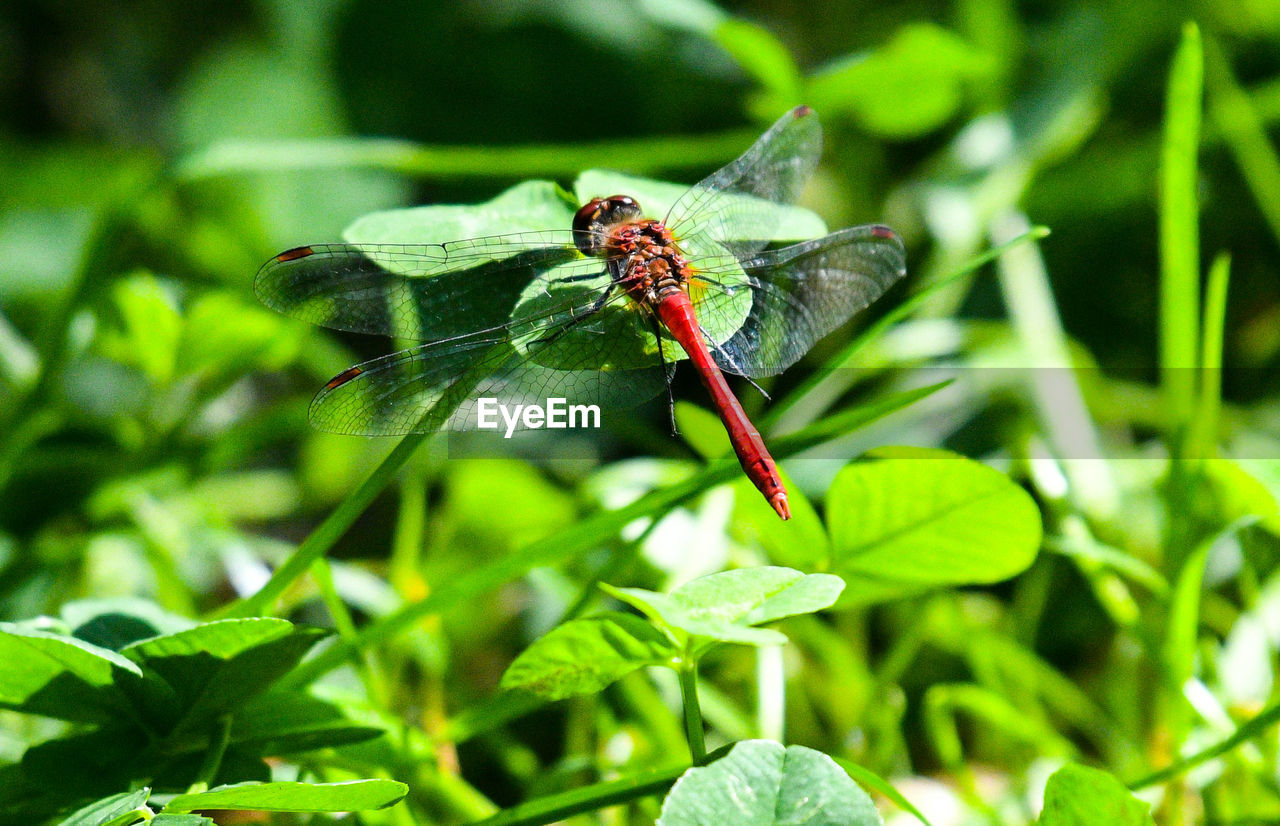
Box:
[658, 740, 883, 826]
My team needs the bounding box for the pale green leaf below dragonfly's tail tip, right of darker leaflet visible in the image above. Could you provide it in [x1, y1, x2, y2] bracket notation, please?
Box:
[600, 567, 845, 645]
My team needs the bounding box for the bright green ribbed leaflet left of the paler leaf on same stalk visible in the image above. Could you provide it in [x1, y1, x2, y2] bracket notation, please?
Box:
[502, 611, 677, 700]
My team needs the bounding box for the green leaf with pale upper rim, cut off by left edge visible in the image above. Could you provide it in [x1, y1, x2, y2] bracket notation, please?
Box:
[0, 622, 142, 724]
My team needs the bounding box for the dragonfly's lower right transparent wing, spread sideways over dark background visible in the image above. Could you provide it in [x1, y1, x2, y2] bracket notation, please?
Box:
[690, 225, 906, 378]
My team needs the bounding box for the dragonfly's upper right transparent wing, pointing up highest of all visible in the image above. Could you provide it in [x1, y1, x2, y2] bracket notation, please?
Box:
[666, 106, 822, 257]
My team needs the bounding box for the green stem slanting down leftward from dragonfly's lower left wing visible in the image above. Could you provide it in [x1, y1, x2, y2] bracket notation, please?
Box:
[218, 433, 429, 619]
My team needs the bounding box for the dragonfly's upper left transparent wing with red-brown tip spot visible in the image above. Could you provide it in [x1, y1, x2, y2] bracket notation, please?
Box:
[253, 229, 604, 341]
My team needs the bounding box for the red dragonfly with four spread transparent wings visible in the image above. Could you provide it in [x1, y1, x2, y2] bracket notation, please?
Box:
[255, 106, 906, 520]
